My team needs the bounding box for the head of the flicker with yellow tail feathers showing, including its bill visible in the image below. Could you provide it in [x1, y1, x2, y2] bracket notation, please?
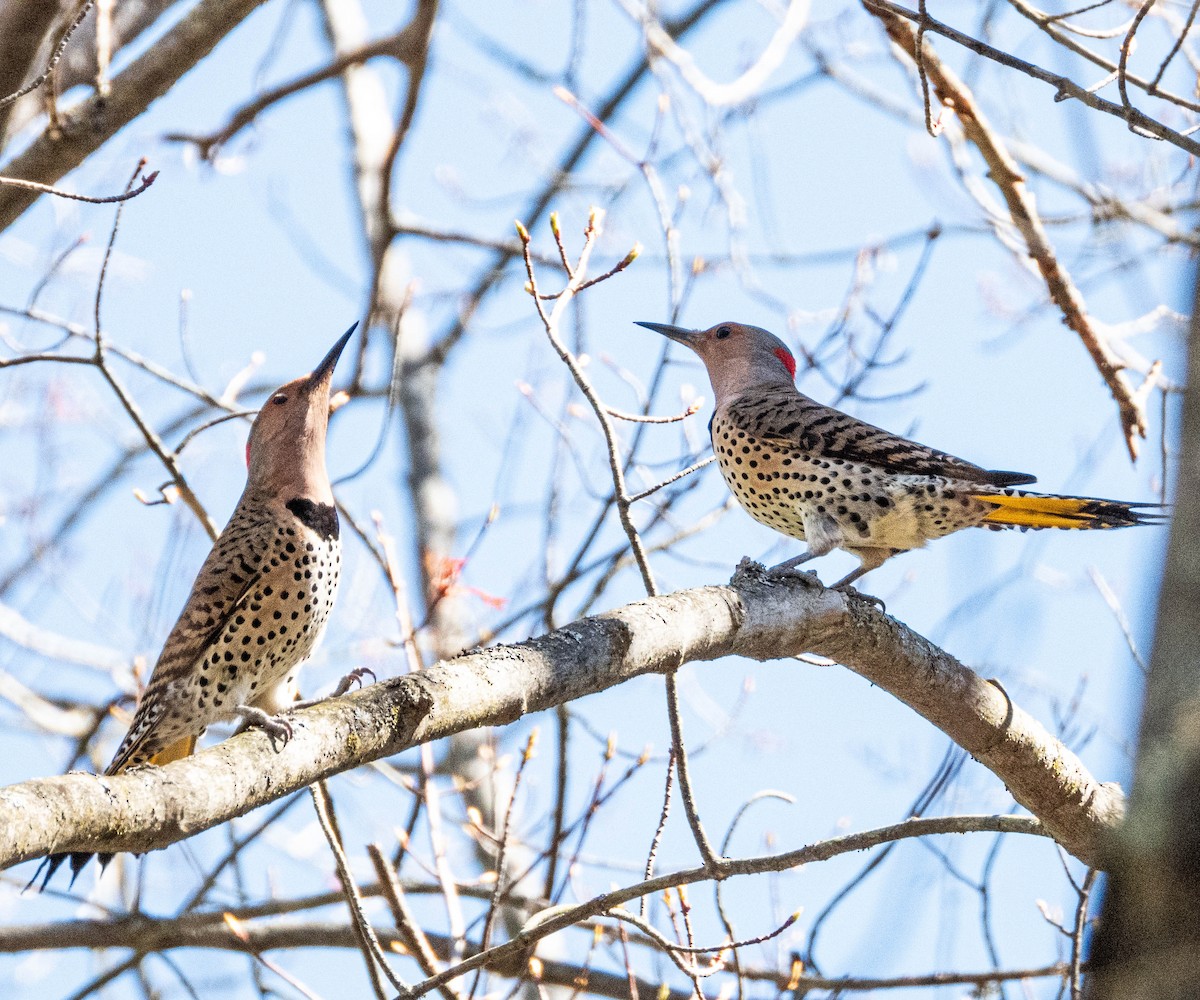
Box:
[637, 323, 796, 406]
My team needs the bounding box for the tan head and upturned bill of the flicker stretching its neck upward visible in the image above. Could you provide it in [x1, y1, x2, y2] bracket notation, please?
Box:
[246, 323, 359, 503]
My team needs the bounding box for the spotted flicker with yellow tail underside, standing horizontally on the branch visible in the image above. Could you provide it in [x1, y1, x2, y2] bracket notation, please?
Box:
[637, 323, 1163, 589]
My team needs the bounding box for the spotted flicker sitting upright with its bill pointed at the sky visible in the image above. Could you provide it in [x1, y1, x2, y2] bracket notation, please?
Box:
[30, 323, 358, 888]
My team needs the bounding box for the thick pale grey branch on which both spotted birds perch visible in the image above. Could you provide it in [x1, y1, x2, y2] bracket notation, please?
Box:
[0, 563, 1124, 868]
